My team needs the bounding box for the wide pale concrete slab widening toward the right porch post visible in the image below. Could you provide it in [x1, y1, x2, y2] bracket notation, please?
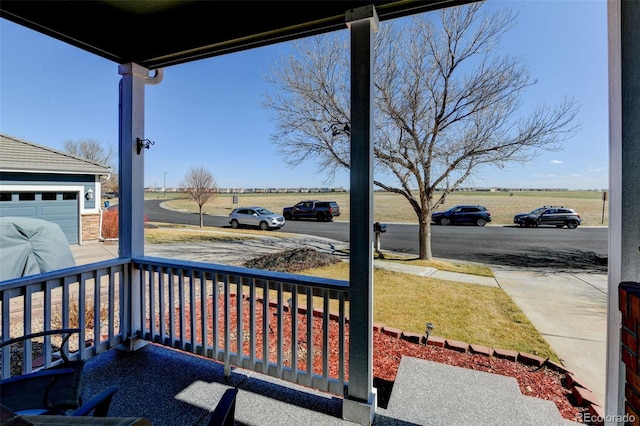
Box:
[492, 268, 608, 404]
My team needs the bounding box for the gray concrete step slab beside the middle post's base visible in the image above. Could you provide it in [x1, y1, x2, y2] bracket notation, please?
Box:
[374, 357, 571, 426]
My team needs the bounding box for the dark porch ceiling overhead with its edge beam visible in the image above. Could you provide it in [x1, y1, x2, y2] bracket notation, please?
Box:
[0, 0, 475, 69]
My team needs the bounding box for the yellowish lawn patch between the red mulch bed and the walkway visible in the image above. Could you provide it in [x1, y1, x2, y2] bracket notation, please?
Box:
[301, 262, 559, 362]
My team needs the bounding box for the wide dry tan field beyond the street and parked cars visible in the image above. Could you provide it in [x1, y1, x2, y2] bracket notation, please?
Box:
[162, 191, 608, 226]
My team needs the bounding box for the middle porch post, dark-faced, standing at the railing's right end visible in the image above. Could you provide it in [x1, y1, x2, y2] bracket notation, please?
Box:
[342, 6, 378, 425]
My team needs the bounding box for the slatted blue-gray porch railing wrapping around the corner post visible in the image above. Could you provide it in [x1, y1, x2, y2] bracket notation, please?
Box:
[0, 257, 349, 395]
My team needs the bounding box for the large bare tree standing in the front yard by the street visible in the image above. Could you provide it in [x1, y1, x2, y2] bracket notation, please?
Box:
[265, 3, 579, 259]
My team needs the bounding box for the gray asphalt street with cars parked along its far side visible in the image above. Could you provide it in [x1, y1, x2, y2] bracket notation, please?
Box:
[145, 199, 609, 274]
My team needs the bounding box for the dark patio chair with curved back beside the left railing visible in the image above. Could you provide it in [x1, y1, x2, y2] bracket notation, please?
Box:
[0, 328, 84, 414]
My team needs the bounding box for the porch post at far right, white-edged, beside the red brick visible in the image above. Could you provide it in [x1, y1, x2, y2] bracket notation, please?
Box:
[605, 0, 640, 424]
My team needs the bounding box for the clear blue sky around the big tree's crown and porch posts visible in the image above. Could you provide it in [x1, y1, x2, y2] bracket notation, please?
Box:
[0, 0, 608, 189]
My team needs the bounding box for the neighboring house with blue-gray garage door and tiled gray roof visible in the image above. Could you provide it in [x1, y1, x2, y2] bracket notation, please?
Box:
[0, 134, 111, 244]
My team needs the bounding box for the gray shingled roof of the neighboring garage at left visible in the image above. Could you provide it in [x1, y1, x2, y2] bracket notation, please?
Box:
[0, 134, 112, 175]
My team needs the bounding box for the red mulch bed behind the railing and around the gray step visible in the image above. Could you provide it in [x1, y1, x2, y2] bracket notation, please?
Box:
[174, 294, 585, 423]
